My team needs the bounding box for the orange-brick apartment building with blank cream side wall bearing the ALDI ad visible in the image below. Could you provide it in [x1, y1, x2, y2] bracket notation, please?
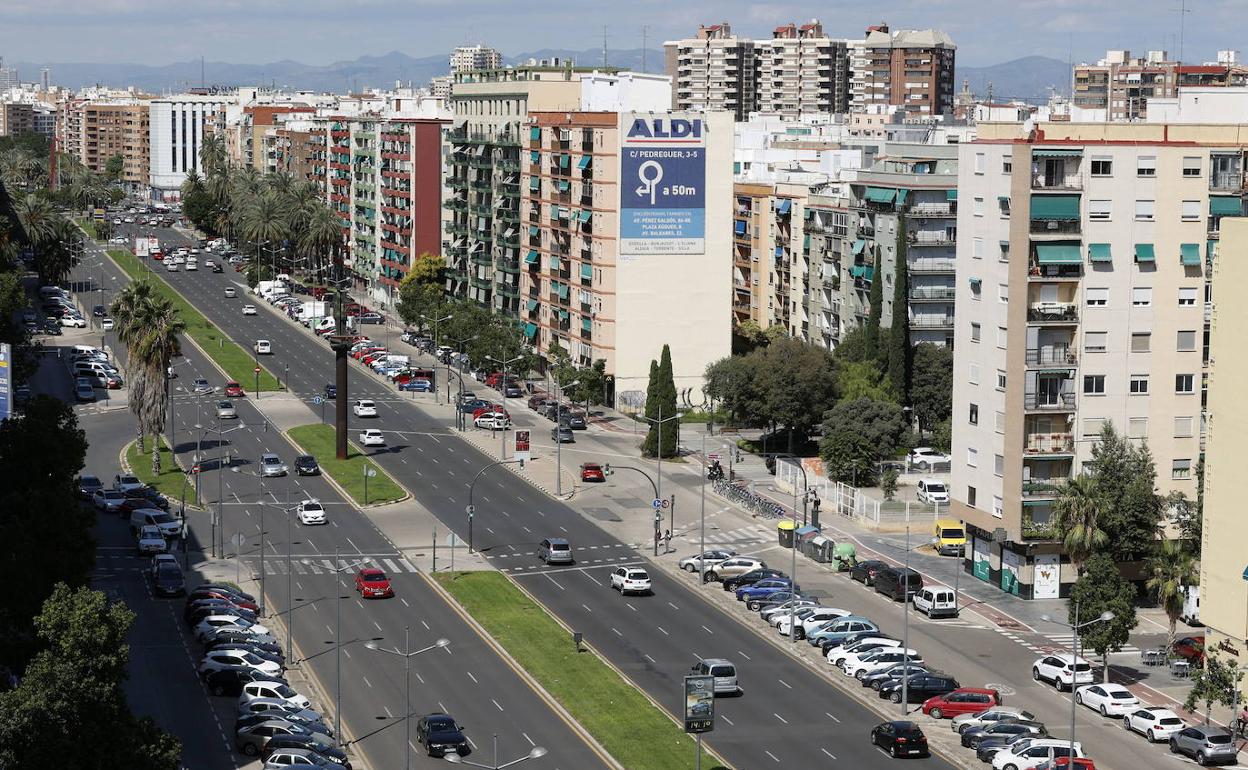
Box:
[521, 111, 733, 402]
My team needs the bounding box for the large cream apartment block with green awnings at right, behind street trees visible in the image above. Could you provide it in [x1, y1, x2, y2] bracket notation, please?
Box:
[951, 119, 1248, 598]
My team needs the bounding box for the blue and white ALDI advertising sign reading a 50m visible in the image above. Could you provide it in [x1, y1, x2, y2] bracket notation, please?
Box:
[619, 114, 706, 255]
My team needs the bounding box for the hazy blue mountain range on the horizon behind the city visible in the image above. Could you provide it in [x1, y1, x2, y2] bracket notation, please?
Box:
[16, 49, 1070, 101]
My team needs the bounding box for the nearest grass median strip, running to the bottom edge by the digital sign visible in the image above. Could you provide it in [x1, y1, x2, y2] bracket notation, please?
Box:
[436, 572, 721, 770]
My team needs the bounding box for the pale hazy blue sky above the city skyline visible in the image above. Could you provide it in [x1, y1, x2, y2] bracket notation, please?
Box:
[0, 0, 1248, 66]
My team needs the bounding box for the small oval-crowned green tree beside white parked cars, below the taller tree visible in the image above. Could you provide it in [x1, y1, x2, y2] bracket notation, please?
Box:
[1067, 553, 1139, 681]
